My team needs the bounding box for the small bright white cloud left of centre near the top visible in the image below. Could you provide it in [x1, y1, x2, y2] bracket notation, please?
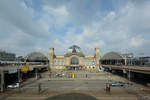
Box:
[42, 5, 69, 29]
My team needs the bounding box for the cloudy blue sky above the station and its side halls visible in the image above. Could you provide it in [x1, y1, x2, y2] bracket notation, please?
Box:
[0, 0, 150, 55]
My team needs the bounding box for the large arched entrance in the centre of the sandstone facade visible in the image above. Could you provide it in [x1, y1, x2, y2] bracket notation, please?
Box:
[70, 57, 79, 70]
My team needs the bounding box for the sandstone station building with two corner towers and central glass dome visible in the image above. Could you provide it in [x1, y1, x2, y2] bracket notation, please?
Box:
[49, 45, 100, 70]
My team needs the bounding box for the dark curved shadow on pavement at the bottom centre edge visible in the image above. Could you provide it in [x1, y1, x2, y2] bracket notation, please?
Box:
[45, 93, 98, 100]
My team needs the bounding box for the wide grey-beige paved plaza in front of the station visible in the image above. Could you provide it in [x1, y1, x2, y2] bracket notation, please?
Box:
[0, 71, 150, 100]
